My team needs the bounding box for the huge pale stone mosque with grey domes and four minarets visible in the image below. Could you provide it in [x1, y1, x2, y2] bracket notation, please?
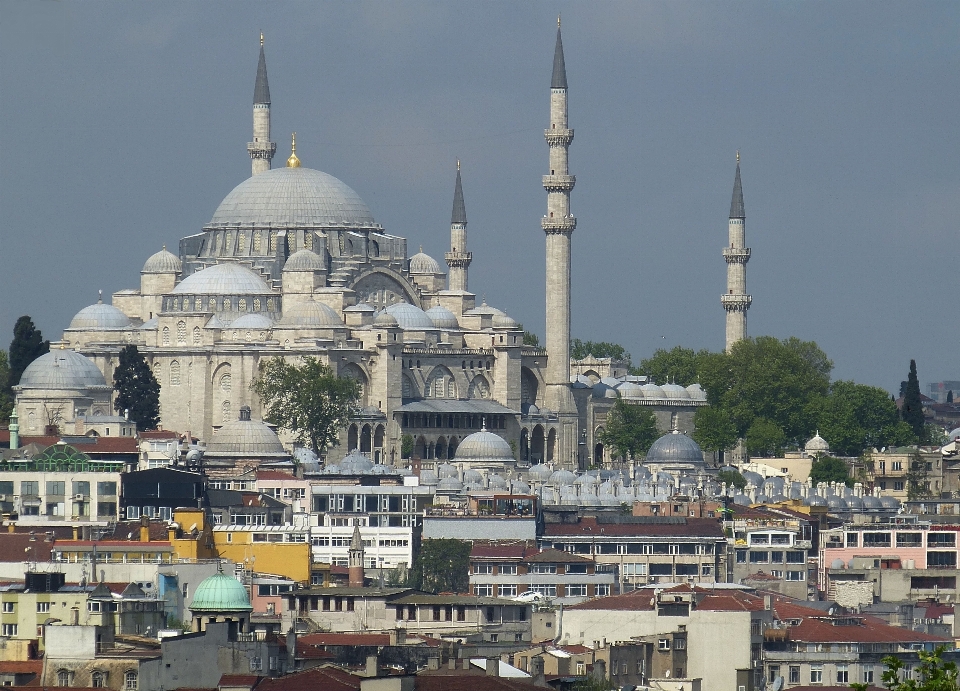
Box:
[11, 27, 750, 471]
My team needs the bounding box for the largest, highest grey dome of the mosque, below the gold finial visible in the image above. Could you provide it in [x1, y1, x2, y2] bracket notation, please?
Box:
[206, 168, 380, 230]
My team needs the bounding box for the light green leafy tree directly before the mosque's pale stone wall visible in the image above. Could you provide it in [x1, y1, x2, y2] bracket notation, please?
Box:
[250, 356, 360, 456]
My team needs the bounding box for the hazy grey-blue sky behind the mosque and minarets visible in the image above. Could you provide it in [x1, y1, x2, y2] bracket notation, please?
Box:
[0, 0, 960, 391]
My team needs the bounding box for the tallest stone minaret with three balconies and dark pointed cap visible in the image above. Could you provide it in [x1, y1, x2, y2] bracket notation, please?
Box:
[541, 19, 577, 466]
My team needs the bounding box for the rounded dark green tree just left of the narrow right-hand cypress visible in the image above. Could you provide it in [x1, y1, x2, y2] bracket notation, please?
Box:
[811, 381, 916, 456]
